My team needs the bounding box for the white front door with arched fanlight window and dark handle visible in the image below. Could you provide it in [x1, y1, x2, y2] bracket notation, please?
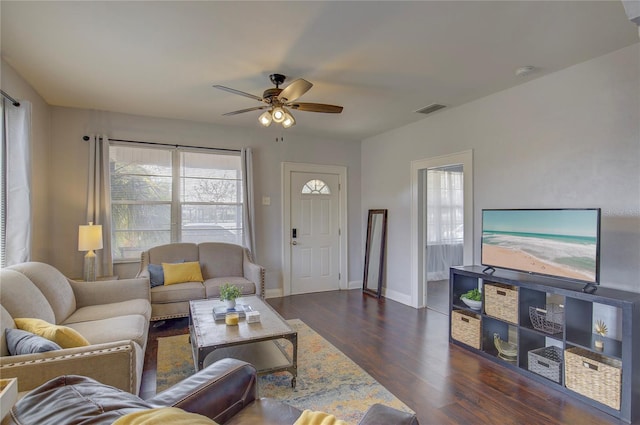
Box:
[289, 172, 340, 294]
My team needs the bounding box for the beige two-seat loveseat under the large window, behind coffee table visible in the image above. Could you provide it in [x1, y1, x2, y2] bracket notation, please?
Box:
[138, 242, 264, 321]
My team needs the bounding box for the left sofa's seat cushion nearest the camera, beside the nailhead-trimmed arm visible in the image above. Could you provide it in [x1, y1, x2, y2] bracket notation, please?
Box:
[68, 314, 148, 347]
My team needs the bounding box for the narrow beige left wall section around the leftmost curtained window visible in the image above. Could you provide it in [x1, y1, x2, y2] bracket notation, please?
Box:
[2, 60, 53, 262]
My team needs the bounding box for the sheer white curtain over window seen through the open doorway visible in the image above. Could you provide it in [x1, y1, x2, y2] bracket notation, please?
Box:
[426, 166, 464, 281]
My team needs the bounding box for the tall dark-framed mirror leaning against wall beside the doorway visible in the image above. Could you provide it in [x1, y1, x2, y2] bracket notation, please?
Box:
[362, 210, 387, 298]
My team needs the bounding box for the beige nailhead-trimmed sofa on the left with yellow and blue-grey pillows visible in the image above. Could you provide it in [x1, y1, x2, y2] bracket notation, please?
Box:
[0, 262, 151, 394]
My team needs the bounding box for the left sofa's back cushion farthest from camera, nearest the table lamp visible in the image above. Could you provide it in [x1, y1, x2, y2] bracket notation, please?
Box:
[9, 262, 76, 323]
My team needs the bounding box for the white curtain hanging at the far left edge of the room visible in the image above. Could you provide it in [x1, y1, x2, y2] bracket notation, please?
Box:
[0, 98, 31, 266]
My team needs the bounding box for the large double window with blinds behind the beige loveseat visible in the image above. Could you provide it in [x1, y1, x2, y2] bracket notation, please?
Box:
[109, 144, 243, 261]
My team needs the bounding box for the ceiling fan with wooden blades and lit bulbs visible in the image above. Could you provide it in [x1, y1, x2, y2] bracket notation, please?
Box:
[213, 74, 342, 128]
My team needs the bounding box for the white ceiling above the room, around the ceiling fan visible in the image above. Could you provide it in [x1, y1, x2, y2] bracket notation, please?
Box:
[0, 0, 638, 140]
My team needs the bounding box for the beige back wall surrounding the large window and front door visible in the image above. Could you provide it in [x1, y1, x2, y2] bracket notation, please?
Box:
[49, 107, 362, 290]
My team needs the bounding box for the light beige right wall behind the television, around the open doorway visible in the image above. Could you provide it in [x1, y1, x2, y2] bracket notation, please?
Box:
[362, 44, 640, 301]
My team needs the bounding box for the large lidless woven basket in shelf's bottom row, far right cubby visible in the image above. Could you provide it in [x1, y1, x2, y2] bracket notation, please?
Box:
[564, 347, 622, 410]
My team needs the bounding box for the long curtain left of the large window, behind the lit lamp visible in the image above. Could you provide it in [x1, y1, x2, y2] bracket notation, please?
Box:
[81, 134, 113, 276]
